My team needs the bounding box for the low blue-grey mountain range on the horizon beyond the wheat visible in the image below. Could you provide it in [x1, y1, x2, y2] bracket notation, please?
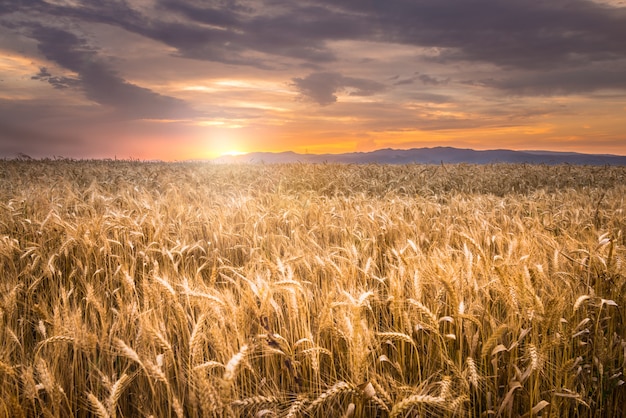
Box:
[212, 147, 626, 165]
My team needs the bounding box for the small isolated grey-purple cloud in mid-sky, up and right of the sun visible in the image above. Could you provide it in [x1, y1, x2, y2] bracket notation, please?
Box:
[293, 72, 385, 106]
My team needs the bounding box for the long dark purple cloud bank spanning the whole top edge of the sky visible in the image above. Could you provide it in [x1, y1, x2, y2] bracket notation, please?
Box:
[7, 0, 626, 77]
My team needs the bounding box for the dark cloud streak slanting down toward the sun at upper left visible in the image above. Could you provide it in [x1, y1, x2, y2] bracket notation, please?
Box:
[26, 24, 194, 119]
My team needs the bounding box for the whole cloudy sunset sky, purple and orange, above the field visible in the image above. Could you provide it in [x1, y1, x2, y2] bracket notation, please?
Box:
[0, 0, 626, 161]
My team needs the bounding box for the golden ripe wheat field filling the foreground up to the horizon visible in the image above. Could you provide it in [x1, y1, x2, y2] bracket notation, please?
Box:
[0, 160, 626, 418]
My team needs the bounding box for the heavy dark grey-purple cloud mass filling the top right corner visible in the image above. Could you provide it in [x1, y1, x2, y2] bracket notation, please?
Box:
[322, 0, 626, 69]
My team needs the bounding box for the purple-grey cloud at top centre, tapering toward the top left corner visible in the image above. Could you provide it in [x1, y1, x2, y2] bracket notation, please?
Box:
[3, 0, 360, 69]
